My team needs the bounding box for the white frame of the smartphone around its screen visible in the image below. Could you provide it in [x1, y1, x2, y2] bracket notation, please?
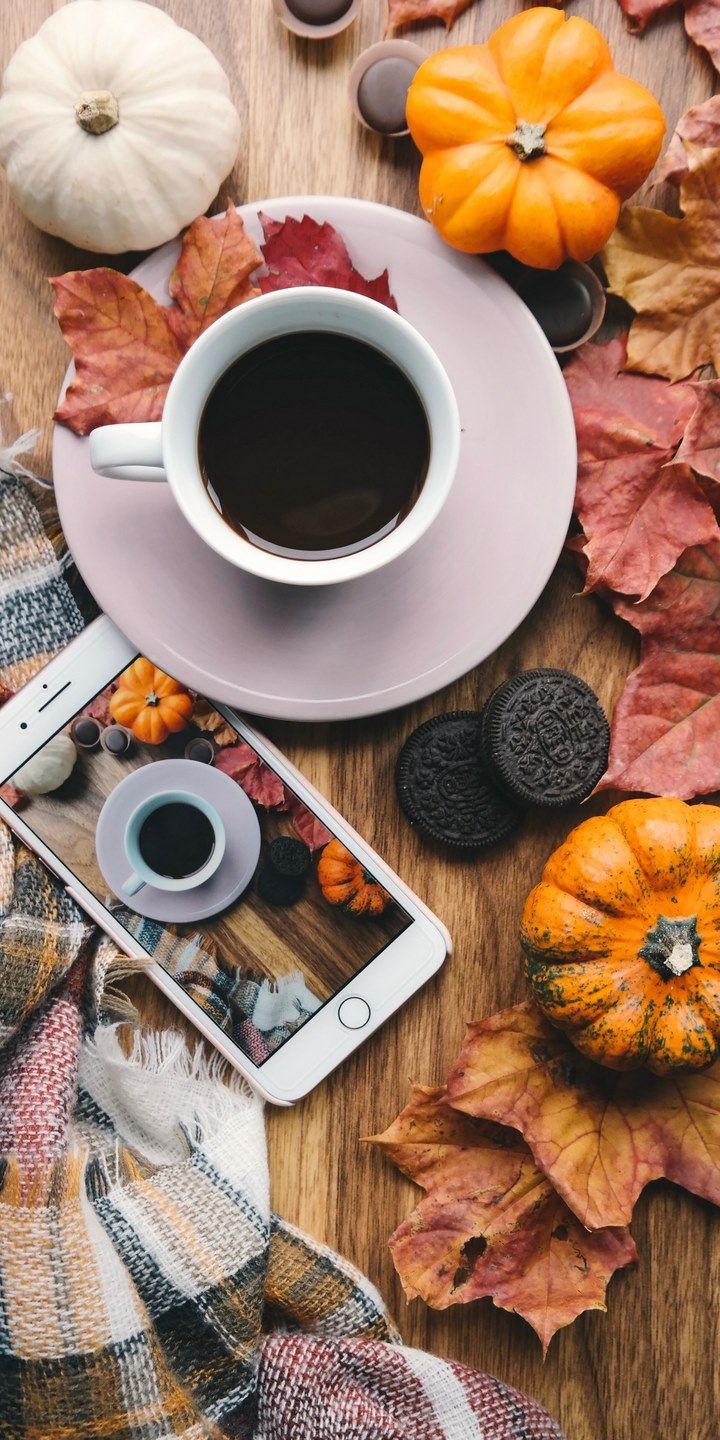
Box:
[0, 615, 452, 1106]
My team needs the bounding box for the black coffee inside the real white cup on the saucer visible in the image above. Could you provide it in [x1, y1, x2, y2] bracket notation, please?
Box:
[199, 331, 429, 559]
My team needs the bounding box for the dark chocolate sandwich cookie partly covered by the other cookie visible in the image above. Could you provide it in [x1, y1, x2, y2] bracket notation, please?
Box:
[395, 710, 523, 850]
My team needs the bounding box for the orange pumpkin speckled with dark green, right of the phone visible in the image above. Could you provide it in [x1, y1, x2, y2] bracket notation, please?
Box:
[521, 799, 720, 1074]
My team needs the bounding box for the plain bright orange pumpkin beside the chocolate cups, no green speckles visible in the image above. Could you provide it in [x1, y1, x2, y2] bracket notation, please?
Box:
[408, 6, 665, 269]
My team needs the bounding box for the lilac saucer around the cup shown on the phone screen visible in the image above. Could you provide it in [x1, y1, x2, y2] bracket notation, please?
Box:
[95, 760, 261, 924]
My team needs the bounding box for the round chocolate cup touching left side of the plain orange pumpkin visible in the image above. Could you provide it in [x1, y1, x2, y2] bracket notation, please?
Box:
[348, 40, 428, 140]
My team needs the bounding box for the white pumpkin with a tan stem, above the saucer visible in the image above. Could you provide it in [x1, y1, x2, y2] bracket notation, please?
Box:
[0, 0, 240, 255]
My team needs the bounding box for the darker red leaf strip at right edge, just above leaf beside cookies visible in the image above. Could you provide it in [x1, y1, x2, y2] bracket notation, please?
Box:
[611, 531, 720, 645]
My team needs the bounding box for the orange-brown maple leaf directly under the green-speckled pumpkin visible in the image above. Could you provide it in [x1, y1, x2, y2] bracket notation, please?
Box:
[448, 1002, 720, 1230]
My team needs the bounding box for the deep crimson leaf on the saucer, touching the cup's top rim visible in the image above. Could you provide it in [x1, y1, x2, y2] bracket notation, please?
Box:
[258, 215, 397, 310]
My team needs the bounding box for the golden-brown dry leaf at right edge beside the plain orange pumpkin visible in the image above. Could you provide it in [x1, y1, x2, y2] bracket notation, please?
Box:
[603, 145, 720, 380]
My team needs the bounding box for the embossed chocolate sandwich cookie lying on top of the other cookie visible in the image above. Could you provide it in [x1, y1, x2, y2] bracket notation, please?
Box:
[481, 670, 611, 808]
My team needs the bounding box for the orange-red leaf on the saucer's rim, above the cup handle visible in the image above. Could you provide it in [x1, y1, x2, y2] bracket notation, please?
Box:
[50, 204, 262, 435]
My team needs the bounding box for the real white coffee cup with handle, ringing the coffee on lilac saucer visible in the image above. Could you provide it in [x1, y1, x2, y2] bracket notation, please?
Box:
[91, 285, 461, 585]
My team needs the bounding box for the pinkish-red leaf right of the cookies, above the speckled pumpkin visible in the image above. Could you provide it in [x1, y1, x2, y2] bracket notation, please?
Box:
[598, 636, 720, 801]
